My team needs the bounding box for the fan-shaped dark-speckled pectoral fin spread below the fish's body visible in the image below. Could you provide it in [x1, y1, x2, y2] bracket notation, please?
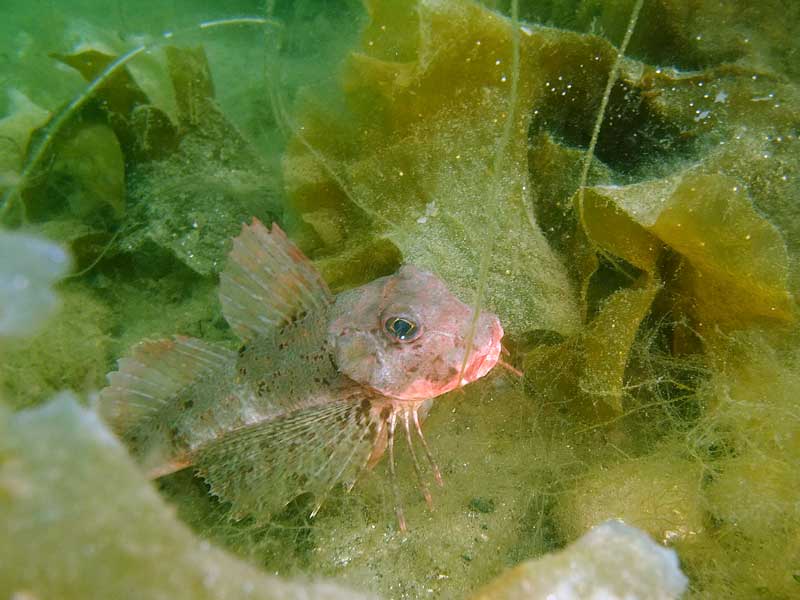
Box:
[193, 398, 379, 522]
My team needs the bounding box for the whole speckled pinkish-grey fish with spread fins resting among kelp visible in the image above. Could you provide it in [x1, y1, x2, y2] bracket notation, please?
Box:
[98, 218, 503, 531]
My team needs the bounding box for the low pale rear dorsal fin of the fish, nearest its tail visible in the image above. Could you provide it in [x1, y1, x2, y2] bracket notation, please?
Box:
[100, 336, 236, 434]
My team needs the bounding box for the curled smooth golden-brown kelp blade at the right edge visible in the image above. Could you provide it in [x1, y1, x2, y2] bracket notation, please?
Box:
[583, 169, 794, 328]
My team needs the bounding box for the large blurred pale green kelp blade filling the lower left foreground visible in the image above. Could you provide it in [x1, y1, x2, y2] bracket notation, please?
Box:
[0, 394, 374, 600]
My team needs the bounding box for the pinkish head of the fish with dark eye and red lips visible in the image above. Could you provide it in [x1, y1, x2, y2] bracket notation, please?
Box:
[328, 265, 503, 400]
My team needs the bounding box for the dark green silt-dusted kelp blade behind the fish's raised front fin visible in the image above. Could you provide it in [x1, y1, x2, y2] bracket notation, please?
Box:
[119, 47, 281, 275]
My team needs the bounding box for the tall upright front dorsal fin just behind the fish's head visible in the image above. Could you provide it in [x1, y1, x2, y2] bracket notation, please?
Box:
[220, 218, 332, 341]
